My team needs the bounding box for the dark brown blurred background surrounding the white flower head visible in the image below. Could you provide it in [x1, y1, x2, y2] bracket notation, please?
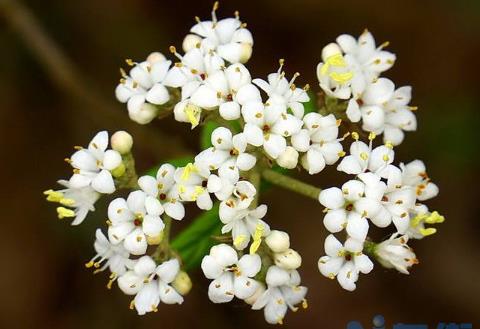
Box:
[0, 0, 480, 329]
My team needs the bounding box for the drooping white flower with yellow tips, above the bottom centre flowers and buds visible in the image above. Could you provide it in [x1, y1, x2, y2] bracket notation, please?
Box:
[220, 205, 270, 250]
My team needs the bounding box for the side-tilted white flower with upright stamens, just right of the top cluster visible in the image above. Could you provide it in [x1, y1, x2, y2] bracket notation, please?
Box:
[253, 60, 310, 119]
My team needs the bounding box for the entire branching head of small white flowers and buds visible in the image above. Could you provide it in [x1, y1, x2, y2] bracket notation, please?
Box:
[45, 3, 444, 324]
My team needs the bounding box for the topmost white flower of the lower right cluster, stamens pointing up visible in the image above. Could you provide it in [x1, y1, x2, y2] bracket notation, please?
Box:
[337, 133, 395, 178]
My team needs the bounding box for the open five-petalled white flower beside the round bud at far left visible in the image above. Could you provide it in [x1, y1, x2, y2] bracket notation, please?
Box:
[68, 131, 122, 194]
